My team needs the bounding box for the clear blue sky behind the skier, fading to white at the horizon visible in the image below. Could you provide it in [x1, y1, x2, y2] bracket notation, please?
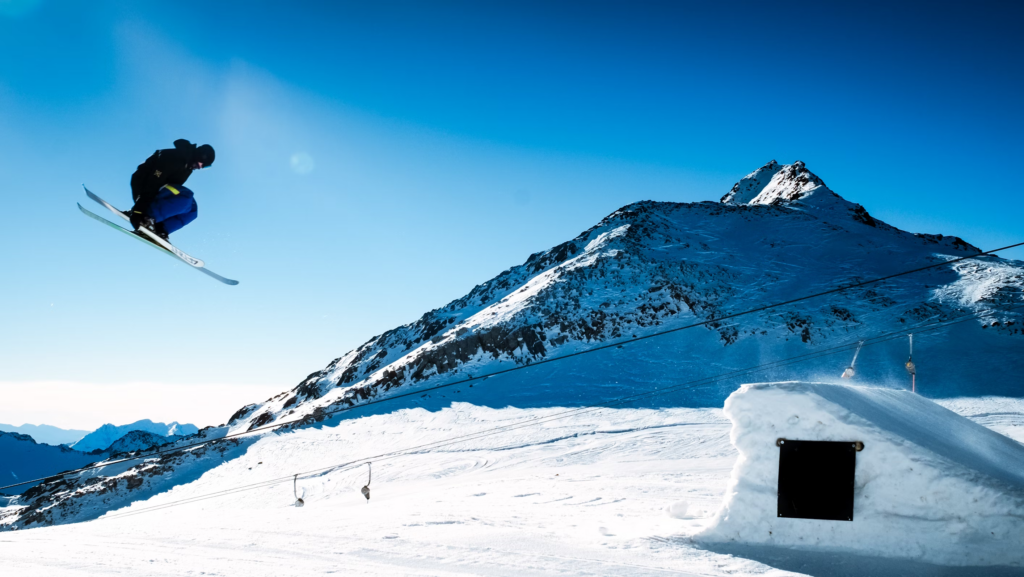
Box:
[0, 0, 1024, 426]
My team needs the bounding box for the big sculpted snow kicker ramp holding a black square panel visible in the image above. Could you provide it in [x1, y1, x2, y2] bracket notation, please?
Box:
[695, 382, 1024, 567]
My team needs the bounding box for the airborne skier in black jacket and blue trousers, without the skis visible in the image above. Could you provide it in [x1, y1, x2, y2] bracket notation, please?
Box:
[128, 138, 214, 240]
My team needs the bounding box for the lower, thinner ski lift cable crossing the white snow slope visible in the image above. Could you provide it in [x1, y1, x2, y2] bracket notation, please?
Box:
[93, 305, 1024, 521]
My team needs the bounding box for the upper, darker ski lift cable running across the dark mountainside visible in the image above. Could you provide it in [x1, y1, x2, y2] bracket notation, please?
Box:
[0, 242, 1024, 491]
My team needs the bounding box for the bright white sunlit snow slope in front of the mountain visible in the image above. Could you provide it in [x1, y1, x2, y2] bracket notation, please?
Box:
[0, 398, 1024, 577]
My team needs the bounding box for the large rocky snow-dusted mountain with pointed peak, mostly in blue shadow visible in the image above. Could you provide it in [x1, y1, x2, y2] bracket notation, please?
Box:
[0, 161, 1024, 529]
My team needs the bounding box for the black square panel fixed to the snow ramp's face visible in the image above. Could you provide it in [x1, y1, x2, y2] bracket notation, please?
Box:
[776, 439, 863, 521]
